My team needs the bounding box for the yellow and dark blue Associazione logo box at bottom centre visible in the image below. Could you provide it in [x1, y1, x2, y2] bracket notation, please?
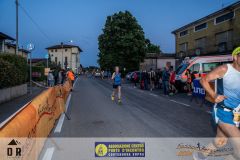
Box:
[95, 142, 145, 157]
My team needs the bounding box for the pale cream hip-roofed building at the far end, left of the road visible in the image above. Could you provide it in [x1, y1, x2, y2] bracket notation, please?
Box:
[46, 44, 82, 73]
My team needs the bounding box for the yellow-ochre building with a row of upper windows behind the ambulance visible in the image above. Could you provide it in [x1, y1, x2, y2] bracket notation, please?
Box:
[172, 1, 240, 58]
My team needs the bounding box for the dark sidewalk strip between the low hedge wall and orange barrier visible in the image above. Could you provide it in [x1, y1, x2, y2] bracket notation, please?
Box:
[0, 87, 44, 124]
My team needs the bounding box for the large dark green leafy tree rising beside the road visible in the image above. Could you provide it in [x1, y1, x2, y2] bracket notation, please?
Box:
[98, 11, 146, 71]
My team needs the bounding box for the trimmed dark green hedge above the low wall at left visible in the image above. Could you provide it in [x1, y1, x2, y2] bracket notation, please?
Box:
[0, 54, 27, 88]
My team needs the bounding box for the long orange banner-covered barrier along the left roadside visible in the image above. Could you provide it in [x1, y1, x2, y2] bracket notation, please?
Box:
[0, 81, 71, 159]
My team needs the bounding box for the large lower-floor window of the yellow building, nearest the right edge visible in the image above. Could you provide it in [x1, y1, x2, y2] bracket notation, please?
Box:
[216, 30, 233, 52]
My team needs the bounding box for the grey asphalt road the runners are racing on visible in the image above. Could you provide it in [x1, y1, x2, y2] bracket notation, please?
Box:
[52, 77, 214, 137]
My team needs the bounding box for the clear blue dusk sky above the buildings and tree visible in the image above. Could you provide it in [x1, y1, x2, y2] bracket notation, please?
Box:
[0, 0, 236, 66]
